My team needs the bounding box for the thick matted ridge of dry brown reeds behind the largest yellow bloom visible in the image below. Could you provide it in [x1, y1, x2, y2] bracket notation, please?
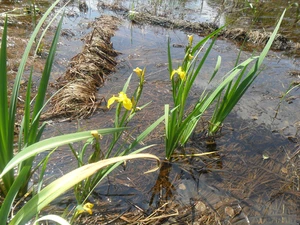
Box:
[43, 15, 120, 118]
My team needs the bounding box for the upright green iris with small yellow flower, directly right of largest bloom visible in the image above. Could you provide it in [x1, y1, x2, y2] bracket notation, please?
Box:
[165, 28, 222, 159]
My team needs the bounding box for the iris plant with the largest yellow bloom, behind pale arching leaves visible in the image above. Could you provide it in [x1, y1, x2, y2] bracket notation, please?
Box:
[70, 68, 164, 207]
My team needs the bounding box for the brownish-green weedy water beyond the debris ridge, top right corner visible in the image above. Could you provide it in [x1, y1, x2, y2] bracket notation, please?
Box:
[207, 0, 300, 42]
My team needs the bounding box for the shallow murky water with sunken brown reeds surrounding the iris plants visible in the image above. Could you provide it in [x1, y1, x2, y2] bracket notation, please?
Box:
[1, 0, 300, 224]
